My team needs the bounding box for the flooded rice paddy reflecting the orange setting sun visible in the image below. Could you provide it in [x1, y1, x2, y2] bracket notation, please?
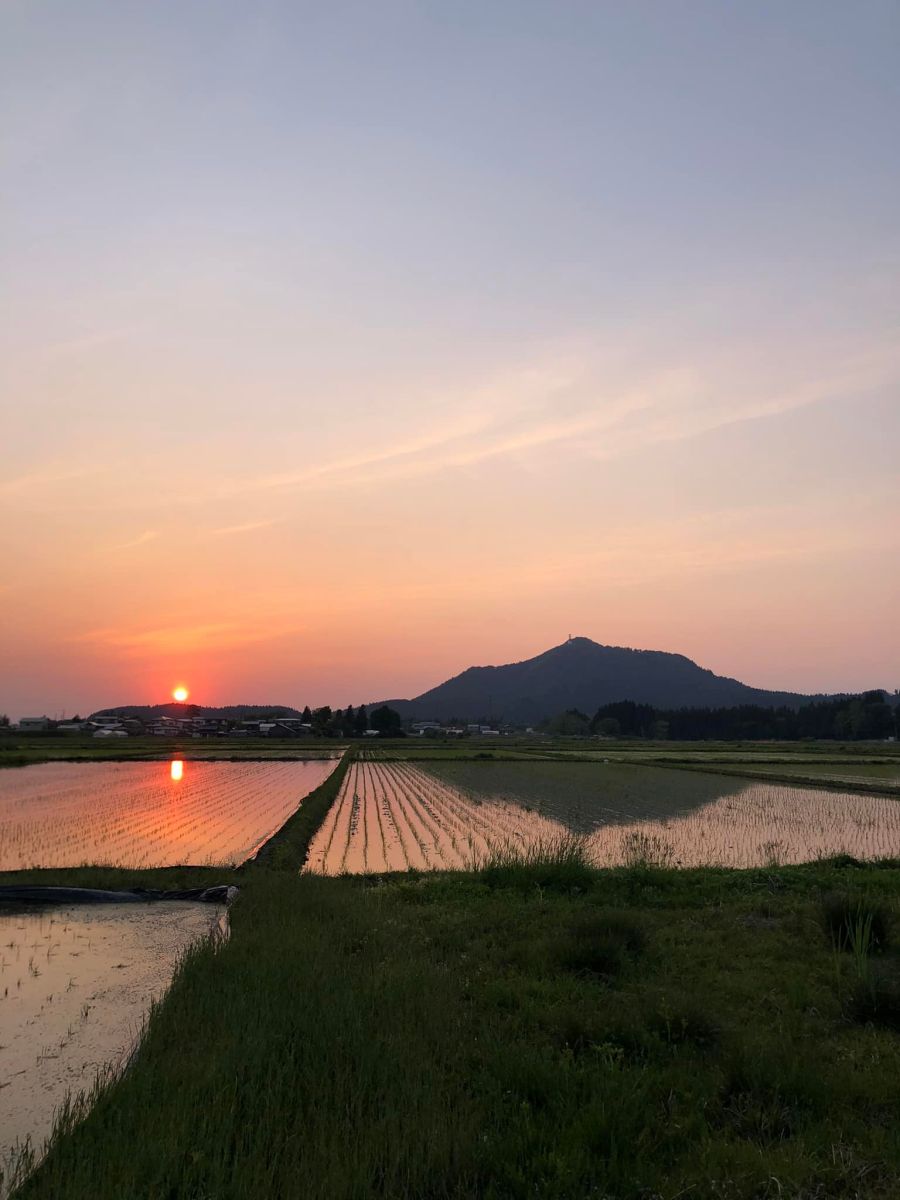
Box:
[0, 760, 337, 871]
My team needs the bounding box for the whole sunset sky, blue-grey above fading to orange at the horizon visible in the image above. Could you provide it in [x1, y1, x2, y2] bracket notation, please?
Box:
[0, 0, 900, 716]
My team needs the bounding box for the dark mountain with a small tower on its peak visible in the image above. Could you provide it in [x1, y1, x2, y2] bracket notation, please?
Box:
[368, 637, 840, 725]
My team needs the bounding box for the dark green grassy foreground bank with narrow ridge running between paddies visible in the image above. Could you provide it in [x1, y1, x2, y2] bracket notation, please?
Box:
[10, 744, 900, 1200]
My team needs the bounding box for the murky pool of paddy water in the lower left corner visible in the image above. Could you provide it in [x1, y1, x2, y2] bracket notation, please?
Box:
[0, 901, 222, 1196]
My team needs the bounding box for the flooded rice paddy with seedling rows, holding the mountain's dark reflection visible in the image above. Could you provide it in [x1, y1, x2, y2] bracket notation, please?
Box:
[308, 762, 900, 875]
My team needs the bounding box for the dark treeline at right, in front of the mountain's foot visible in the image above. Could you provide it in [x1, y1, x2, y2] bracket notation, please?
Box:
[588, 691, 900, 742]
